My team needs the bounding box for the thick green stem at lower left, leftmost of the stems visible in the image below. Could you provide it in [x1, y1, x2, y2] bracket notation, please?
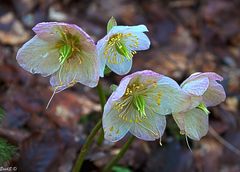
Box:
[72, 120, 102, 172]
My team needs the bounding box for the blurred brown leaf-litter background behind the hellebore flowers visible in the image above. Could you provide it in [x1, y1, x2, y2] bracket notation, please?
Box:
[0, 0, 240, 172]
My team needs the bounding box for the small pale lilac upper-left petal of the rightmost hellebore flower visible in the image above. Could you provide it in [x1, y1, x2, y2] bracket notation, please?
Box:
[181, 75, 209, 96]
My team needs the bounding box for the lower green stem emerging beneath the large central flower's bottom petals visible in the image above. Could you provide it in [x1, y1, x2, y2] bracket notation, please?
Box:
[103, 136, 135, 172]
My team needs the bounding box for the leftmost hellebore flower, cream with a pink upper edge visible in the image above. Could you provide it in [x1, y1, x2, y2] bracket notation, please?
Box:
[17, 22, 99, 92]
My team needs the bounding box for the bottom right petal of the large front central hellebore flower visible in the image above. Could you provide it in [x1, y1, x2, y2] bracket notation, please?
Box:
[130, 108, 166, 141]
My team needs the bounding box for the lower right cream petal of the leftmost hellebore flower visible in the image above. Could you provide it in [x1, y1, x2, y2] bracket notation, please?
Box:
[50, 52, 99, 92]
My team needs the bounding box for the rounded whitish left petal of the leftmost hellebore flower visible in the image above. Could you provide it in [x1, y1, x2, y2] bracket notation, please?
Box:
[16, 36, 60, 76]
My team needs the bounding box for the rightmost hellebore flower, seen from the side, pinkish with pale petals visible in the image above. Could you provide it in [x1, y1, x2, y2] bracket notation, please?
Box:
[173, 72, 226, 140]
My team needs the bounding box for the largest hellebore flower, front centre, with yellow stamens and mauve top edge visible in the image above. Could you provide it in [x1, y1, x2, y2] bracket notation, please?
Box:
[102, 70, 189, 142]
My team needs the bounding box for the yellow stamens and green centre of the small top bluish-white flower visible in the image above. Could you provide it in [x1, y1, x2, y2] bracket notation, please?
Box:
[104, 33, 139, 64]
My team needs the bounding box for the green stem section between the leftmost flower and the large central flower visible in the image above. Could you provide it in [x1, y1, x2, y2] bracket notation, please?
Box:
[97, 81, 106, 145]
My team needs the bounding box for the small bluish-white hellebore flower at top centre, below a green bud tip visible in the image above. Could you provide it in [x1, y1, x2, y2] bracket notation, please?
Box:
[97, 25, 150, 77]
